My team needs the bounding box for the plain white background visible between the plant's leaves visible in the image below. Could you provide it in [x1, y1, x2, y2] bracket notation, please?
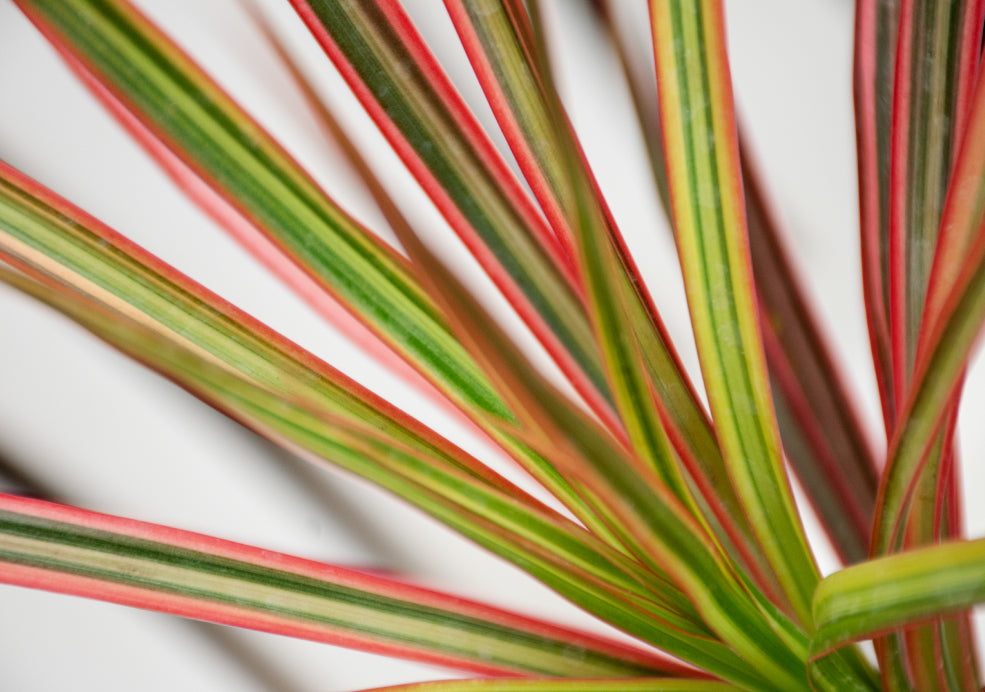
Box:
[0, 0, 985, 692]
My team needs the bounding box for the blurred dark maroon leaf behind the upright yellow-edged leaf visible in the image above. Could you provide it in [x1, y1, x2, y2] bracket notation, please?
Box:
[592, 0, 878, 563]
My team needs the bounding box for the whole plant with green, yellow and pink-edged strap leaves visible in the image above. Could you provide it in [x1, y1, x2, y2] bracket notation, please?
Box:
[0, 0, 985, 692]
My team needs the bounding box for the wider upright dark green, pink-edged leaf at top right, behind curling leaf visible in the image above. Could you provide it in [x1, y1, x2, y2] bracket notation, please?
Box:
[880, 0, 982, 690]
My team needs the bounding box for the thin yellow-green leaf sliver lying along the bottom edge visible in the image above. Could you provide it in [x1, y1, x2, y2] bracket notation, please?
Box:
[364, 678, 741, 692]
